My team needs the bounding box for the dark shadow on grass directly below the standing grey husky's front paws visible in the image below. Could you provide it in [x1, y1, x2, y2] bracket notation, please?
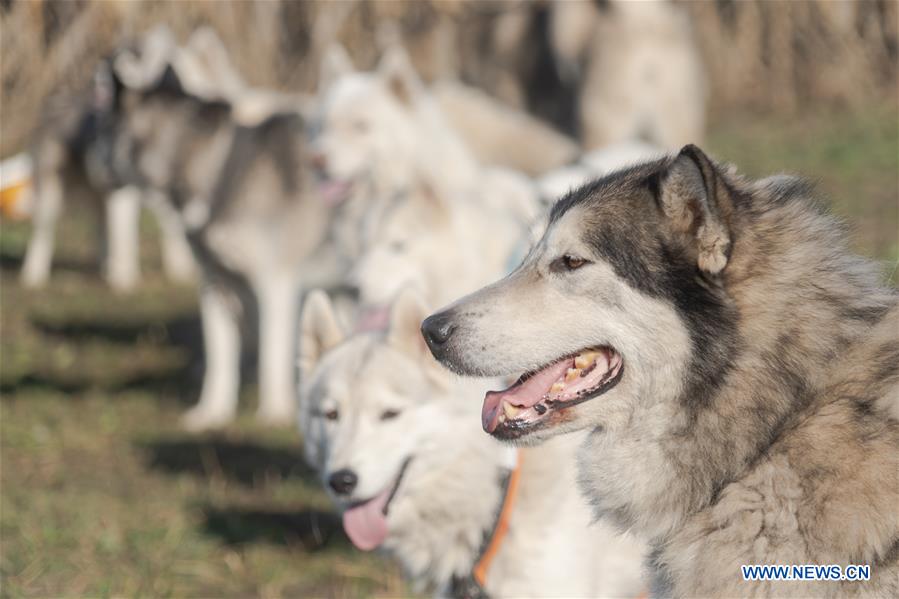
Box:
[139, 437, 318, 487]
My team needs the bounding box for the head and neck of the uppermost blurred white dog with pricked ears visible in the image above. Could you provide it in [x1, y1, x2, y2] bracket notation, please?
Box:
[314, 46, 479, 216]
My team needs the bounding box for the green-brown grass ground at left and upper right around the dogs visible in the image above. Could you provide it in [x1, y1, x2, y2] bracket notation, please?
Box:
[0, 105, 899, 597]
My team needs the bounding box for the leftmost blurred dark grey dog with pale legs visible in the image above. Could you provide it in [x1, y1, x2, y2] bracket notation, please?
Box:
[21, 30, 194, 291]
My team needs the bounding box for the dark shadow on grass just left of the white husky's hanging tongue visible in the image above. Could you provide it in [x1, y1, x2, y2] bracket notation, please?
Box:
[203, 506, 349, 551]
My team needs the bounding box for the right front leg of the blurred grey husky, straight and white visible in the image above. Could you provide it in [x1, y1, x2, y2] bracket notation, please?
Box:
[254, 272, 299, 424]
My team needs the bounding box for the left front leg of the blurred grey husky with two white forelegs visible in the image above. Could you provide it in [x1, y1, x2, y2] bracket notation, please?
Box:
[182, 284, 240, 431]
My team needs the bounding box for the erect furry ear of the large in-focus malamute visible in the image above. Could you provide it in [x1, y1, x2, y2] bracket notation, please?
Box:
[659, 145, 733, 275]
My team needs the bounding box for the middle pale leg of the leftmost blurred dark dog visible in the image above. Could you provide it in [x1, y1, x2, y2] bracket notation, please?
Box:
[104, 185, 140, 292]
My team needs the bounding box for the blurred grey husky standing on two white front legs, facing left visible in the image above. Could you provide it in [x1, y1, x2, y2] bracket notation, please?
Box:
[116, 57, 341, 429]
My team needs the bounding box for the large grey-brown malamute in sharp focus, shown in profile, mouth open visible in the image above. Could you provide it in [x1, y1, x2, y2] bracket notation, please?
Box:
[422, 146, 899, 597]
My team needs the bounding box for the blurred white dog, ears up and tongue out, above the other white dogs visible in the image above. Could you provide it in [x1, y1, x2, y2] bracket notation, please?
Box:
[313, 46, 537, 264]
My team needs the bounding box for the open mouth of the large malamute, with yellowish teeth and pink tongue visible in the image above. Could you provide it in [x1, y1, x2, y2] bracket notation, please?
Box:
[481, 347, 624, 439]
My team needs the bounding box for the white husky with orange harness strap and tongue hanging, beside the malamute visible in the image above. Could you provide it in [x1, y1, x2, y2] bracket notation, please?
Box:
[300, 291, 643, 597]
